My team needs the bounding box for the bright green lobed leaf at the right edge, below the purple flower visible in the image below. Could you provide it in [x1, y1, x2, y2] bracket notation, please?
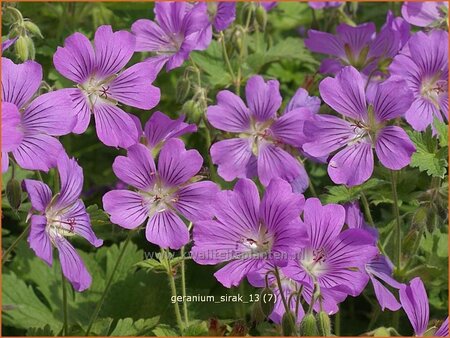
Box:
[409, 128, 447, 178]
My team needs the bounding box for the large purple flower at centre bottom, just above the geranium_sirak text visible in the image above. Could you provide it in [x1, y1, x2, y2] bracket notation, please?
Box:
[191, 179, 304, 288]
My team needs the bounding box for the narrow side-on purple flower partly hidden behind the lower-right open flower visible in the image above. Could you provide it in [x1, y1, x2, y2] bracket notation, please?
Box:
[344, 202, 402, 311]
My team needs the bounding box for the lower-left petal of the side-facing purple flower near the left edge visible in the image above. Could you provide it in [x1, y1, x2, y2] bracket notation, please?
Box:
[28, 215, 53, 266]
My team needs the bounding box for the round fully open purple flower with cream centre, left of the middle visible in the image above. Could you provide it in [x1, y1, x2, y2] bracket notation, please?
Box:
[103, 139, 217, 249]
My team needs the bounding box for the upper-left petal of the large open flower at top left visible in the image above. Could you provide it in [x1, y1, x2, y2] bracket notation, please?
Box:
[53, 33, 95, 84]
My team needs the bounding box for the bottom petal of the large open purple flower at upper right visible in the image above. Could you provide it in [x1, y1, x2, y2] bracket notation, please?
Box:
[328, 142, 374, 186]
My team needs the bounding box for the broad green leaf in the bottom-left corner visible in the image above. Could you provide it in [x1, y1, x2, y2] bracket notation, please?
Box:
[2, 272, 62, 332]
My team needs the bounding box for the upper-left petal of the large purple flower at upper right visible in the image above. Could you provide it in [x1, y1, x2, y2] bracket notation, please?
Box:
[319, 67, 367, 121]
